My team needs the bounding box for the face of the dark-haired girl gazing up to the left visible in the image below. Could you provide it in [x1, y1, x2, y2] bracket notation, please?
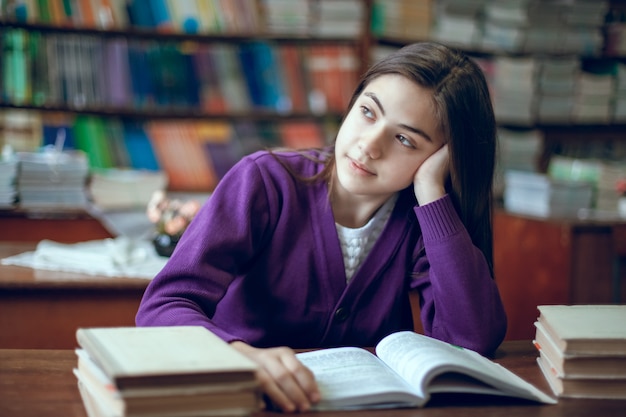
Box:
[335, 74, 444, 197]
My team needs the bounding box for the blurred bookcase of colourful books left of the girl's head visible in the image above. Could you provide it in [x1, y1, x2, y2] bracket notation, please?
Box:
[0, 0, 368, 192]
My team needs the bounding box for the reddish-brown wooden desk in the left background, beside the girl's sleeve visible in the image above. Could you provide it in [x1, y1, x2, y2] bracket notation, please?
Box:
[0, 242, 149, 348]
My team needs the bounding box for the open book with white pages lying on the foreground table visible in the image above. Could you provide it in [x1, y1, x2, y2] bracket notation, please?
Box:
[298, 331, 556, 410]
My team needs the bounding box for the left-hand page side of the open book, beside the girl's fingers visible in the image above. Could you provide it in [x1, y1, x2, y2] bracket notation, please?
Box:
[297, 347, 421, 409]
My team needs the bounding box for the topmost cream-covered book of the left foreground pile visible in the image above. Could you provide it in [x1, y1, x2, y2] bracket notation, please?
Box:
[76, 326, 256, 390]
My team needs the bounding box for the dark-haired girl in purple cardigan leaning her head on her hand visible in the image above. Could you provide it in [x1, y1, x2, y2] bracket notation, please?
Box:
[137, 43, 506, 412]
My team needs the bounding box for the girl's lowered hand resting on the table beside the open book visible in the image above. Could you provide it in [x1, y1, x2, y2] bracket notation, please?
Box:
[231, 341, 320, 413]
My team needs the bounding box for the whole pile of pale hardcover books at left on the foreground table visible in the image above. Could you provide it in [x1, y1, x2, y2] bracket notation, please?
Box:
[74, 326, 261, 417]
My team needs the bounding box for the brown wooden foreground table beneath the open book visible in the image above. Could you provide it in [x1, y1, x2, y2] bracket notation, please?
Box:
[0, 341, 626, 417]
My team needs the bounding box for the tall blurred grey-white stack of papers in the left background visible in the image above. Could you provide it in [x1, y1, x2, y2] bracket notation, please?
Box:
[17, 151, 89, 209]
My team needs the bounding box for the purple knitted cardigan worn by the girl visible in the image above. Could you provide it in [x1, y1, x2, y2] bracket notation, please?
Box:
[136, 152, 506, 354]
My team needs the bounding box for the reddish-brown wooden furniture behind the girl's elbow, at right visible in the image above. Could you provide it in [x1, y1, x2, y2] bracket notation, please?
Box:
[493, 210, 626, 340]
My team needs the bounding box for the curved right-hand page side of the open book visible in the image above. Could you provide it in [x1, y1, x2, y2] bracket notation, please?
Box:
[376, 332, 554, 402]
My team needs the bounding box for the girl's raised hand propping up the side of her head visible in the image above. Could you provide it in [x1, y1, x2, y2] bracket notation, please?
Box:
[413, 144, 450, 205]
